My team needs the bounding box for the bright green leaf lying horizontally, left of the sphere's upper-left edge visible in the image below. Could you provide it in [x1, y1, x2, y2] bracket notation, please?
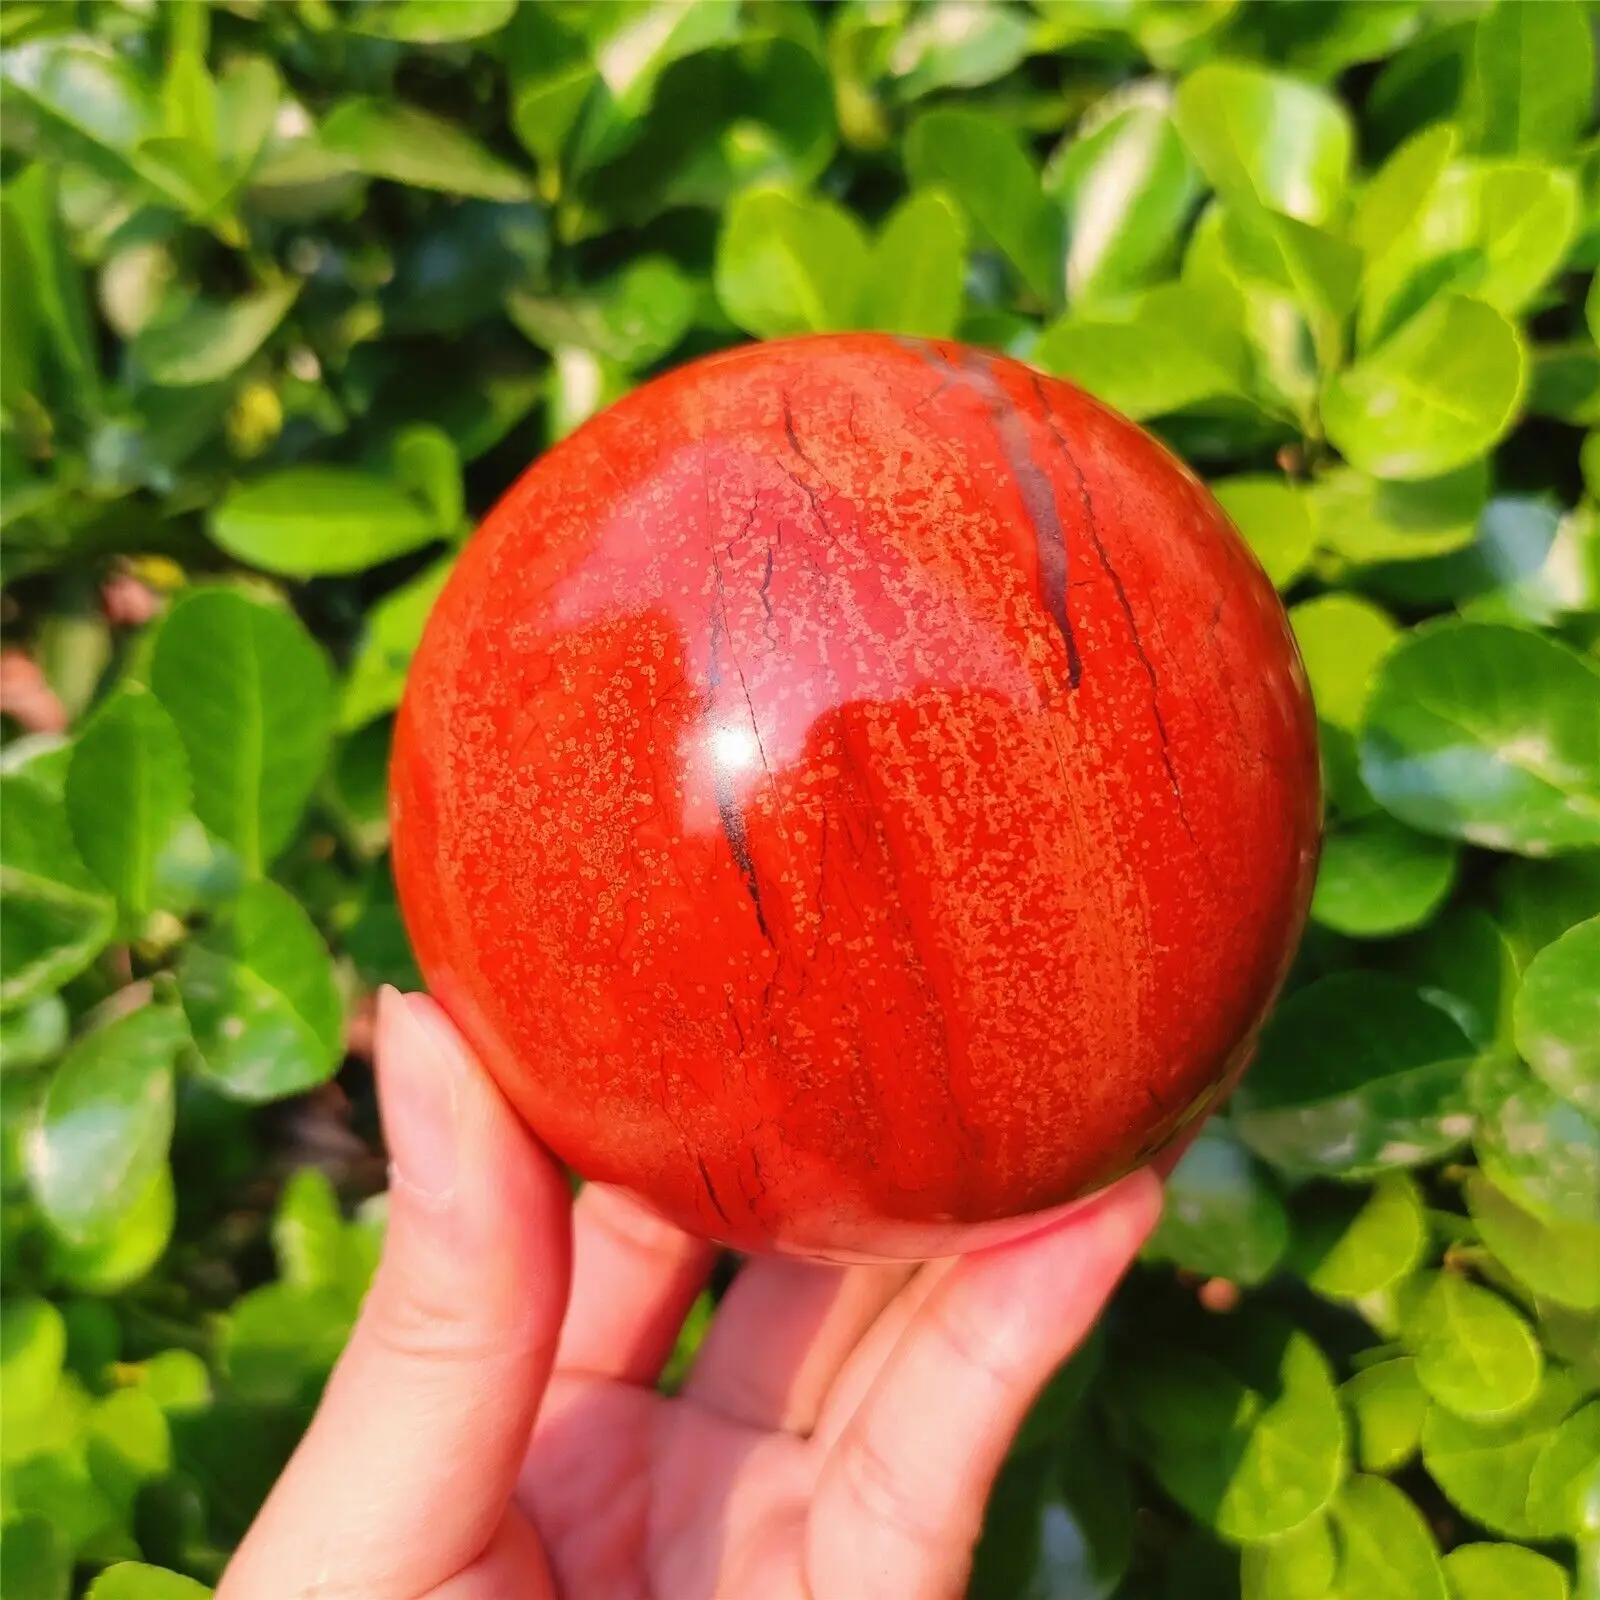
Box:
[211, 466, 445, 578]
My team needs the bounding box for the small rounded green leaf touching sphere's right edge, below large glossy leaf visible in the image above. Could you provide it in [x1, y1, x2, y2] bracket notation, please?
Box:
[1310, 816, 1456, 939]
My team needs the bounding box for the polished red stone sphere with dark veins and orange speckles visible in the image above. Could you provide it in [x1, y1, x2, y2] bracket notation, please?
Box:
[392, 334, 1320, 1258]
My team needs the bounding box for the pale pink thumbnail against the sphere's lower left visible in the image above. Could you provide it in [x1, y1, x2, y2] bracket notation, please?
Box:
[376, 984, 462, 1200]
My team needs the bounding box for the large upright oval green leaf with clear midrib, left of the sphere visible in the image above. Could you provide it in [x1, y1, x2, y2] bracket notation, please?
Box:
[150, 589, 333, 872]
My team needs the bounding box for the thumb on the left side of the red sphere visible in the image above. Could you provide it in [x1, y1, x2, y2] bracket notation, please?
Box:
[219, 989, 571, 1600]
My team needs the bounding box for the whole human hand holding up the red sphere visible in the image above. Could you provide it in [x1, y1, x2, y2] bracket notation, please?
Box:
[218, 990, 1160, 1600]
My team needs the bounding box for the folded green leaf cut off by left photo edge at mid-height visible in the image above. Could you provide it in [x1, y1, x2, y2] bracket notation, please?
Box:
[0, 774, 117, 1011]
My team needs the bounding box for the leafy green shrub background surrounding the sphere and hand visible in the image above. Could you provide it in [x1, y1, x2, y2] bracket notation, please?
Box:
[0, 0, 1600, 1600]
